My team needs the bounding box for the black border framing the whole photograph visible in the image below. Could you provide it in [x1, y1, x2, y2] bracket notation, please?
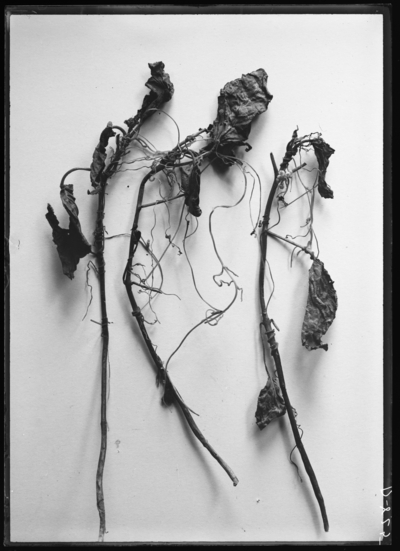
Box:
[3, 3, 393, 548]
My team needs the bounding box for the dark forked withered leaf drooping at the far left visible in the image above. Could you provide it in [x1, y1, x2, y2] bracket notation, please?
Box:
[46, 185, 91, 279]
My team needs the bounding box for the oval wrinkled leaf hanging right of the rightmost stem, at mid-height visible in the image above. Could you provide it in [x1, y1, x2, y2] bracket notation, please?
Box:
[301, 259, 338, 350]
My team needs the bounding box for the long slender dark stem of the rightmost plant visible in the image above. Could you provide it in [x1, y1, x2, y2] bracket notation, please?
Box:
[259, 154, 329, 532]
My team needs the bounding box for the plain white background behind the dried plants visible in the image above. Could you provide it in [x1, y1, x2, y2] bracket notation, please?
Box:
[10, 11, 383, 542]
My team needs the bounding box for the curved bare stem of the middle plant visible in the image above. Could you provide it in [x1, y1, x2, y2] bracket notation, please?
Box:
[123, 153, 239, 486]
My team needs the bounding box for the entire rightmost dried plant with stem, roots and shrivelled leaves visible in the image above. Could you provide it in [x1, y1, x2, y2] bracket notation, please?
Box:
[256, 130, 337, 532]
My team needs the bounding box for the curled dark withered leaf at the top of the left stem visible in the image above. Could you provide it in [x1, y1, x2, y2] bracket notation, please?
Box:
[124, 61, 174, 130]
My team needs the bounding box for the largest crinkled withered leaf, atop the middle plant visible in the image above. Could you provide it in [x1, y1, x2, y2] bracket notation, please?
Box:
[210, 69, 273, 164]
